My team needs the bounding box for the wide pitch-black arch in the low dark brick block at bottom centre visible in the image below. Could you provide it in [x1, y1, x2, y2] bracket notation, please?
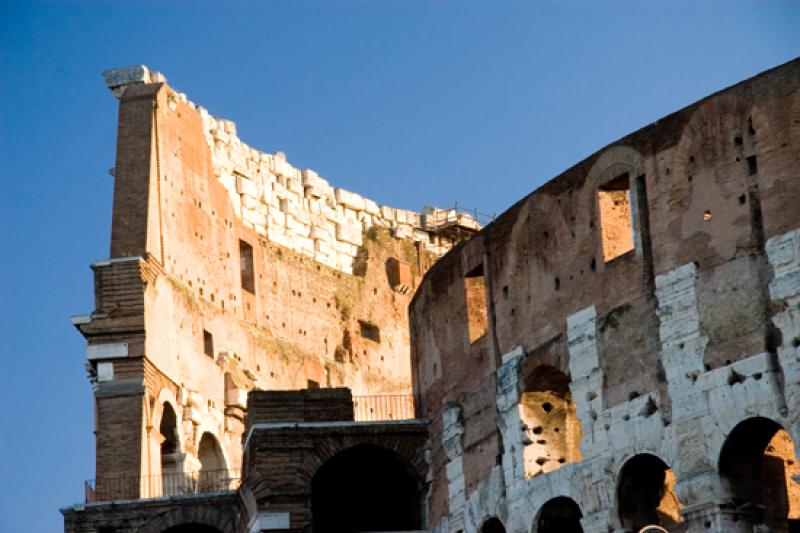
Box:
[311, 444, 422, 533]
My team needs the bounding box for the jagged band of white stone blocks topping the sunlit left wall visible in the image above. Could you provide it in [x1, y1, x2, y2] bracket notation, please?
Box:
[104, 65, 472, 274]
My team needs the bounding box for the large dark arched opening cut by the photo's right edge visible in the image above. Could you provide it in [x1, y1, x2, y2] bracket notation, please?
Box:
[719, 417, 800, 532]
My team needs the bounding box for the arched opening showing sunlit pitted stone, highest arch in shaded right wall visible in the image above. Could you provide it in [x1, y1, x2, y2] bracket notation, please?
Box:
[520, 365, 581, 478]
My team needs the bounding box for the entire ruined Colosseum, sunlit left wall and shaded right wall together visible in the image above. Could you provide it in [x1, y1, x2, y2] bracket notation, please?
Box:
[62, 59, 800, 533]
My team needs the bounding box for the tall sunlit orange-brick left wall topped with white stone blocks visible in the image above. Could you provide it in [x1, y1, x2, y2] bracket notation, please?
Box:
[73, 66, 468, 498]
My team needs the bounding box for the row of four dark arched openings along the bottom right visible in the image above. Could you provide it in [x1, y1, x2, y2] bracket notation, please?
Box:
[472, 418, 800, 533]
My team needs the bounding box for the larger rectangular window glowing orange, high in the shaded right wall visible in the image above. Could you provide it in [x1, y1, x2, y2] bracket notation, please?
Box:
[597, 174, 633, 262]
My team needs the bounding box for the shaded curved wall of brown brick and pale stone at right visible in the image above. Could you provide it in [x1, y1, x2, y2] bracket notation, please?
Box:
[410, 60, 800, 533]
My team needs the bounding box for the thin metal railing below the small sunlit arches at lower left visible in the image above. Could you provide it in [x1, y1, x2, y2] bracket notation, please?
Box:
[85, 470, 241, 503]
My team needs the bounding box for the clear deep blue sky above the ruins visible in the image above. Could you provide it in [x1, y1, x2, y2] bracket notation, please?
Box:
[0, 0, 800, 533]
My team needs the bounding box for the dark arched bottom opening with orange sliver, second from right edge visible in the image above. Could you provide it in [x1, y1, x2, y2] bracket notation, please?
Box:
[617, 453, 685, 531]
